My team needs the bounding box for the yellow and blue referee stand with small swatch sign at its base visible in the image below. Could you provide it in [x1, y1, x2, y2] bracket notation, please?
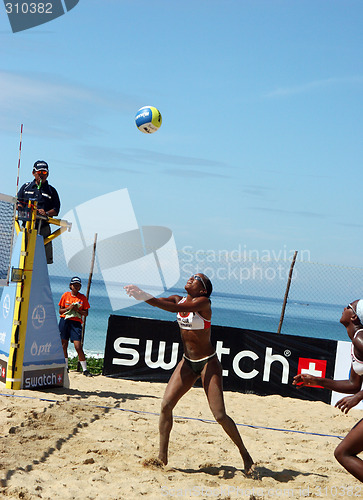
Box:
[0, 201, 71, 390]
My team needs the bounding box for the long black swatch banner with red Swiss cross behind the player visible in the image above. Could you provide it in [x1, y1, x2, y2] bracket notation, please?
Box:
[103, 315, 337, 403]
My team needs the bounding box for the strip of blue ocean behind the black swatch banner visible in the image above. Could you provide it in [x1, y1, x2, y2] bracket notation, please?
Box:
[50, 275, 348, 357]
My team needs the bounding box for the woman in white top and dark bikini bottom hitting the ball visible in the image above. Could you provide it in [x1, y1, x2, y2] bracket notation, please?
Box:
[125, 273, 253, 474]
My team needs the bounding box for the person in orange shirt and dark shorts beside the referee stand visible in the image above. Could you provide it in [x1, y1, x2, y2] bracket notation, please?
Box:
[58, 276, 92, 377]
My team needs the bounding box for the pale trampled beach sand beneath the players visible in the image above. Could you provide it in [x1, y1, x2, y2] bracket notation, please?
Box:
[0, 372, 363, 500]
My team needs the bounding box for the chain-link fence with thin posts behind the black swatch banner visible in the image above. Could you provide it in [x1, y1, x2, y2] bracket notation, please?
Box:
[2, 200, 363, 357]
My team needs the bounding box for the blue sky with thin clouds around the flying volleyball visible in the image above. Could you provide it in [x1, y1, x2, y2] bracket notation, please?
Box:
[0, 0, 363, 267]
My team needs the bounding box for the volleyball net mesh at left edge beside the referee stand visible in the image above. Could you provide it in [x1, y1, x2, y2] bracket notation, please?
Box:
[0, 193, 16, 286]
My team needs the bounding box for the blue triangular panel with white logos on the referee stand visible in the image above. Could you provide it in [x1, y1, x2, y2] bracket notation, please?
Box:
[23, 235, 65, 366]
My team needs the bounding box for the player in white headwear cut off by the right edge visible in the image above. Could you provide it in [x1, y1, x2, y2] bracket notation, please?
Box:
[293, 300, 363, 482]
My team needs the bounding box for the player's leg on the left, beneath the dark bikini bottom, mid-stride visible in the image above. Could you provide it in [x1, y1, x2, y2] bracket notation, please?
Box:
[159, 358, 199, 465]
